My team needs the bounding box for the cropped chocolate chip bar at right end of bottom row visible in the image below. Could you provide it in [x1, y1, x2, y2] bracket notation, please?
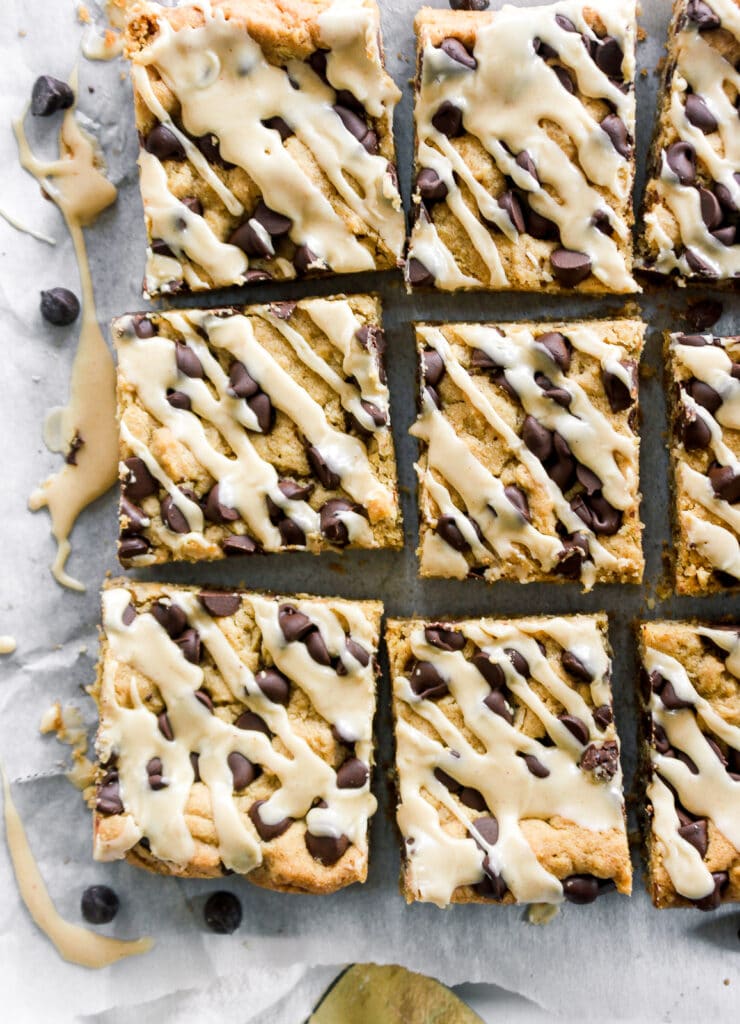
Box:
[639, 622, 740, 910]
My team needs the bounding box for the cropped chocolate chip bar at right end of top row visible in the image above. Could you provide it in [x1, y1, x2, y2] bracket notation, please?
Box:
[640, 0, 740, 284]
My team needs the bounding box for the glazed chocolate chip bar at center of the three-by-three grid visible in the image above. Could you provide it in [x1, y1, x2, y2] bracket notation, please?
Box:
[411, 319, 645, 589]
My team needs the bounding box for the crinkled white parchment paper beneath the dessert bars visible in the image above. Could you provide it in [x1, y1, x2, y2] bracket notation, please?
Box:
[0, 0, 740, 1024]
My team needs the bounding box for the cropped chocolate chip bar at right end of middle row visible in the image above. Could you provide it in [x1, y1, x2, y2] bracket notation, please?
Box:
[665, 334, 740, 594]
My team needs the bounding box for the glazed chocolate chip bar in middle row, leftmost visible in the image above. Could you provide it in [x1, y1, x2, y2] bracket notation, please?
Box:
[113, 296, 403, 565]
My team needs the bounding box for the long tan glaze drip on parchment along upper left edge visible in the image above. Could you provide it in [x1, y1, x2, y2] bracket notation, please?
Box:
[13, 73, 118, 590]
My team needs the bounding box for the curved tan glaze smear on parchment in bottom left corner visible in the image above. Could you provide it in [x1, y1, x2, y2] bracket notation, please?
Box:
[0, 768, 154, 968]
